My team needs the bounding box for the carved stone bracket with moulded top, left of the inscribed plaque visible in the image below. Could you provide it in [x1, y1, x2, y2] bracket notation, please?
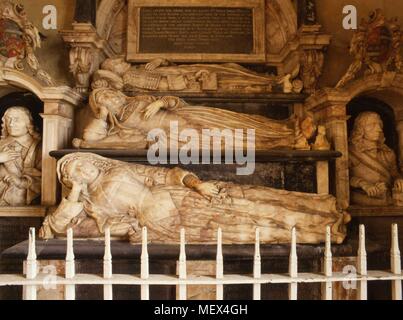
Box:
[60, 23, 111, 93]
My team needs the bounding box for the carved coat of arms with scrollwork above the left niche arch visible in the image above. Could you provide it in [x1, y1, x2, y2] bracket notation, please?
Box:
[0, 1, 54, 86]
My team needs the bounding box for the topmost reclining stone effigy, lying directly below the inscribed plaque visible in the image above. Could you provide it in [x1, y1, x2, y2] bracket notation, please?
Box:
[92, 58, 302, 94]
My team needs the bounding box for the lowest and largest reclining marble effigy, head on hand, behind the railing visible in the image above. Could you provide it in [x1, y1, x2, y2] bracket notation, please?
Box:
[40, 153, 350, 244]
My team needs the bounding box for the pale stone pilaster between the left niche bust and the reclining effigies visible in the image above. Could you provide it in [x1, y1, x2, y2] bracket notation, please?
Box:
[41, 100, 74, 206]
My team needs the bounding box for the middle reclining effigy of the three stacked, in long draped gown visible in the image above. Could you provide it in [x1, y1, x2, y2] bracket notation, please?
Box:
[73, 89, 316, 150]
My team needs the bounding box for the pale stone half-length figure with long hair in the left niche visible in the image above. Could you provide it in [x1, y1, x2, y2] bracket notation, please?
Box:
[0, 107, 42, 206]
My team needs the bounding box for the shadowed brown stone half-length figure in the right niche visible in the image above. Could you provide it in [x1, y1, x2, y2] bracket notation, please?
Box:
[349, 112, 403, 206]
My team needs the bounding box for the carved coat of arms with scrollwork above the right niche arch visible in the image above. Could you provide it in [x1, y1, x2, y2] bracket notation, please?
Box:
[336, 9, 403, 88]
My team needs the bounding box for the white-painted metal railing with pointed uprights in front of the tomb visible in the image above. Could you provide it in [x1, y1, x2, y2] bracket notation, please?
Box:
[0, 224, 403, 300]
